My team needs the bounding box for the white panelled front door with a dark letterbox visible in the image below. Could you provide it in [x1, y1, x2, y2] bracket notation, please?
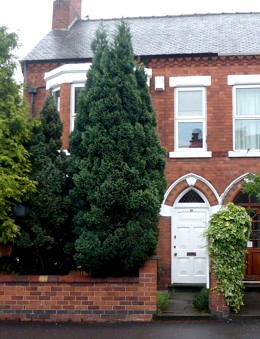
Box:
[172, 207, 208, 285]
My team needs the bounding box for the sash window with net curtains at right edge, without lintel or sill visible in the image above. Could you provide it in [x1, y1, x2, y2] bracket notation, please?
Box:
[233, 85, 260, 151]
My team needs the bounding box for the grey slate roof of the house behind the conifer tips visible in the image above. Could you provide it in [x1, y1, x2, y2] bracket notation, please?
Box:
[24, 13, 260, 61]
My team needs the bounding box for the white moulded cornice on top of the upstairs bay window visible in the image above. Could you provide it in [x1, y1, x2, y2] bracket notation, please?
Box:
[44, 63, 91, 90]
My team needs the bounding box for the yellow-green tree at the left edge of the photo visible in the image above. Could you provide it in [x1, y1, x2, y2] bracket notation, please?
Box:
[0, 27, 34, 244]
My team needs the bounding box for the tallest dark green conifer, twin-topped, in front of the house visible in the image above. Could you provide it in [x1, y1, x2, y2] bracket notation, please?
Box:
[70, 21, 166, 276]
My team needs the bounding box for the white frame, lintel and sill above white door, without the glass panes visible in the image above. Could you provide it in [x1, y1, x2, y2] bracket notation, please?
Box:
[169, 76, 212, 158]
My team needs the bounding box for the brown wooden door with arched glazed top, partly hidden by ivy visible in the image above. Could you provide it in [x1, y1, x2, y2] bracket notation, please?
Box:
[234, 193, 260, 281]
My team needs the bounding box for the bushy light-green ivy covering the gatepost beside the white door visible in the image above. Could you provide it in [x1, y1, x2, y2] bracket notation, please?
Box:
[204, 203, 251, 313]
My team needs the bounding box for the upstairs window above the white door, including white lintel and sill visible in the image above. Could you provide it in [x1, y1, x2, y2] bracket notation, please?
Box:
[169, 75, 212, 158]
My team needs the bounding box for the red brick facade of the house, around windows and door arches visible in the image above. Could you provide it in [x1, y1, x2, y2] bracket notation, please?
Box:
[24, 56, 260, 284]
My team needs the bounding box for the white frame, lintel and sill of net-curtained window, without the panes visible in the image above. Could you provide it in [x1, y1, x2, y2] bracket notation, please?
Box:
[227, 74, 260, 158]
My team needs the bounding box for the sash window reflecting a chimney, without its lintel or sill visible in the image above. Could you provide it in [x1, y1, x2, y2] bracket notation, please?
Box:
[175, 87, 206, 151]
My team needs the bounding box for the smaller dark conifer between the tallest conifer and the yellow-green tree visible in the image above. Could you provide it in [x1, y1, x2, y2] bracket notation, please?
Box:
[15, 95, 71, 274]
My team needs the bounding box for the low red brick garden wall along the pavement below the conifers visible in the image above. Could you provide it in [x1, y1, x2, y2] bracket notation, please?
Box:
[0, 259, 157, 322]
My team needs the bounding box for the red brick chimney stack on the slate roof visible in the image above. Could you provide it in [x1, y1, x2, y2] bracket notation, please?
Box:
[52, 0, 81, 29]
